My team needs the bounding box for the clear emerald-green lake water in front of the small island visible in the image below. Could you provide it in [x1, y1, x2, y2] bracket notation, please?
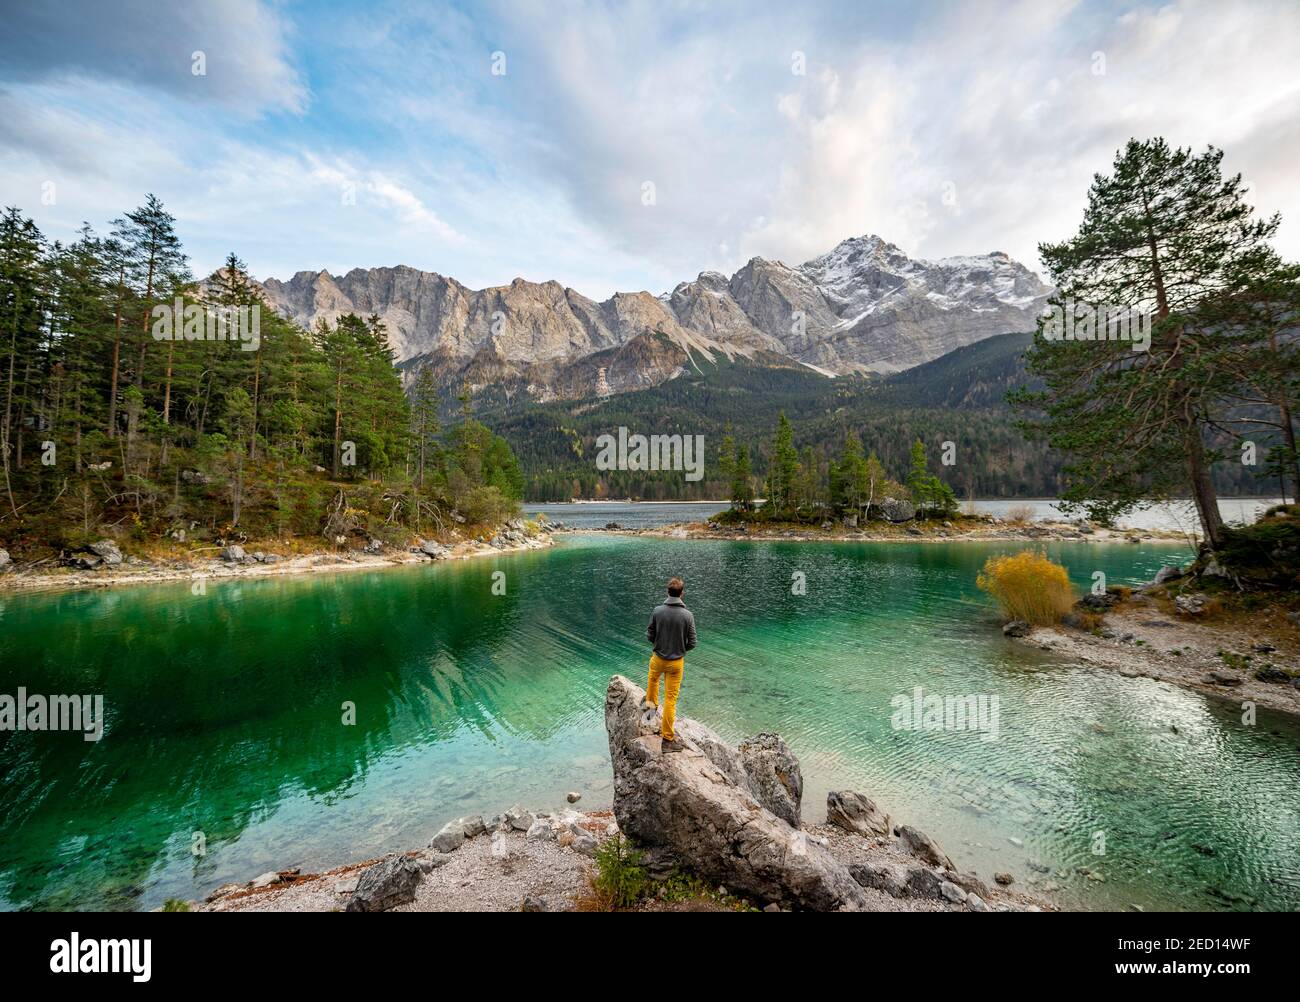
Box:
[0, 535, 1300, 910]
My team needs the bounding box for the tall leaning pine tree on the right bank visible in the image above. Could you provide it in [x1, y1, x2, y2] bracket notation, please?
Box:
[1017, 139, 1279, 547]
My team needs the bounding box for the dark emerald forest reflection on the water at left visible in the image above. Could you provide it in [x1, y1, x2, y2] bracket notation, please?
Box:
[0, 556, 612, 908]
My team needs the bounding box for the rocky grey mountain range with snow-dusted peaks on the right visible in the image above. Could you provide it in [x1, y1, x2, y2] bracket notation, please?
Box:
[263, 235, 1052, 404]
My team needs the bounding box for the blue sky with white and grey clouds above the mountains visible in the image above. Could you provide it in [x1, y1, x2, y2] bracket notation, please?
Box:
[0, 0, 1300, 298]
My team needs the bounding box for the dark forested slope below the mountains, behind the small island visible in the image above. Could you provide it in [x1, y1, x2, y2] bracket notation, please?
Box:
[480, 333, 1281, 500]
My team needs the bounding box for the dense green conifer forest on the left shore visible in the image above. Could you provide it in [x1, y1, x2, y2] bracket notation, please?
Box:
[0, 196, 523, 554]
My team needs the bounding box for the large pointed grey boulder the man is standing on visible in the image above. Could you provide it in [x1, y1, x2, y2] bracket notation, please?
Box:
[605, 674, 867, 911]
